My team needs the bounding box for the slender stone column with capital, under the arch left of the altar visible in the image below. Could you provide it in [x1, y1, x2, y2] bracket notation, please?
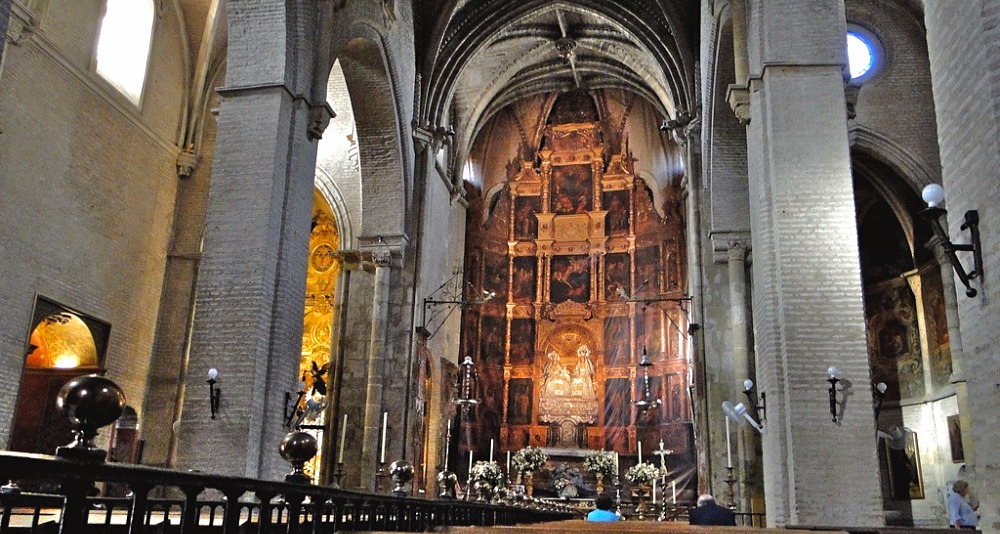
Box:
[361, 248, 392, 490]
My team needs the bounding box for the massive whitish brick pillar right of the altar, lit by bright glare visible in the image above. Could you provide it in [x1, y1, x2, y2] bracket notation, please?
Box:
[747, 0, 885, 527]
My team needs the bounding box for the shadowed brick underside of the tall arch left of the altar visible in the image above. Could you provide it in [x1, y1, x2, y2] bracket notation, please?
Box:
[337, 34, 411, 241]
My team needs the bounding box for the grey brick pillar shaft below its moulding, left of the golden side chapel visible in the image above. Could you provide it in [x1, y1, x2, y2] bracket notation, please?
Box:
[176, 83, 316, 479]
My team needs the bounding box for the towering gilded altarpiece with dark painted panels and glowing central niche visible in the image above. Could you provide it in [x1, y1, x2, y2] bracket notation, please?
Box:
[461, 92, 694, 494]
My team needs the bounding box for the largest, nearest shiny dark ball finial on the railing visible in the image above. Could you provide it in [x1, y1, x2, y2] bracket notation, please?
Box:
[56, 375, 126, 461]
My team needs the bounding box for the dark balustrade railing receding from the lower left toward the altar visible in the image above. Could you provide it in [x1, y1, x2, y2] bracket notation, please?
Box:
[0, 452, 580, 534]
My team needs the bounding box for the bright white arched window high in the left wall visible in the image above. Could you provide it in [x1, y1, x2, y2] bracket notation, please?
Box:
[95, 0, 155, 106]
